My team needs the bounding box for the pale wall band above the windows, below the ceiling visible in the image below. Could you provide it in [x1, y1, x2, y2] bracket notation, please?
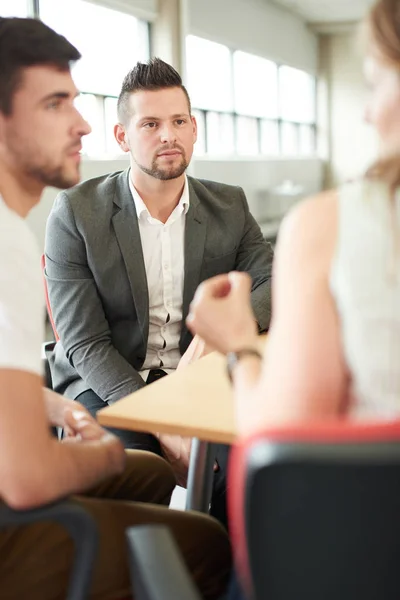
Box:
[186, 0, 318, 73]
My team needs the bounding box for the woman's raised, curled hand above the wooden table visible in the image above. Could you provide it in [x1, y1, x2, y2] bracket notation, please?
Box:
[186, 272, 257, 354]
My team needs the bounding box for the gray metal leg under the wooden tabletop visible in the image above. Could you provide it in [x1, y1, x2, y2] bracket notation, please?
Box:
[186, 438, 215, 513]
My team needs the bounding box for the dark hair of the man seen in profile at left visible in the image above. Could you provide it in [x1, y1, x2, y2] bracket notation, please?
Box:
[0, 17, 81, 115]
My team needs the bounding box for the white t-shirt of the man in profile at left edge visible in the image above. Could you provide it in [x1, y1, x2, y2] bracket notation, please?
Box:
[0, 196, 45, 375]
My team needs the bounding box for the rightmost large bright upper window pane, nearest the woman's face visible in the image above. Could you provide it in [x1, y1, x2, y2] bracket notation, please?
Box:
[279, 66, 315, 123]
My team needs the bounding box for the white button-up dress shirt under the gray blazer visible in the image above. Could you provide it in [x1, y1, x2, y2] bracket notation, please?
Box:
[129, 177, 189, 381]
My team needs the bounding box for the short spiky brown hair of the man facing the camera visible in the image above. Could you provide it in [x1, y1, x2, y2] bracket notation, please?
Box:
[117, 58, 192, 123]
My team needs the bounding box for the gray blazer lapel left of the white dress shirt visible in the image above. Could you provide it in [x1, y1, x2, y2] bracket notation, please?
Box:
[112, 169, 149, 348]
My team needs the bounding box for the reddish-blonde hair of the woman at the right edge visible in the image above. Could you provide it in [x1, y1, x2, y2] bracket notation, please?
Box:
[364, 0, 400, 191]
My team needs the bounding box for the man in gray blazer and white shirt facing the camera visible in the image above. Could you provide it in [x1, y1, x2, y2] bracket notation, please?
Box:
[45, 59, 272, 464]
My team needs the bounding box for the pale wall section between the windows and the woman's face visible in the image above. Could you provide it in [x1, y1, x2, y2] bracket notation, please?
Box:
[319, 30, 377, 187]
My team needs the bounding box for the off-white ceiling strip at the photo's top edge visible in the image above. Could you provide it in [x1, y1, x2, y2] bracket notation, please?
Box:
[273, 0, 372, 24]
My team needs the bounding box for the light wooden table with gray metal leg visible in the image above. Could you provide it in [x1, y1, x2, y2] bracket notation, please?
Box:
[97, 352, 236, 512]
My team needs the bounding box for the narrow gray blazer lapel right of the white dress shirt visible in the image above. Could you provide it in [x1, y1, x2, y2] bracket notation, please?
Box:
[182, 178, 207, 324]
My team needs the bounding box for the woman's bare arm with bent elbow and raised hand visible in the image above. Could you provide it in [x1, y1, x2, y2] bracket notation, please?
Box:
[189, 192, 347, 433]
